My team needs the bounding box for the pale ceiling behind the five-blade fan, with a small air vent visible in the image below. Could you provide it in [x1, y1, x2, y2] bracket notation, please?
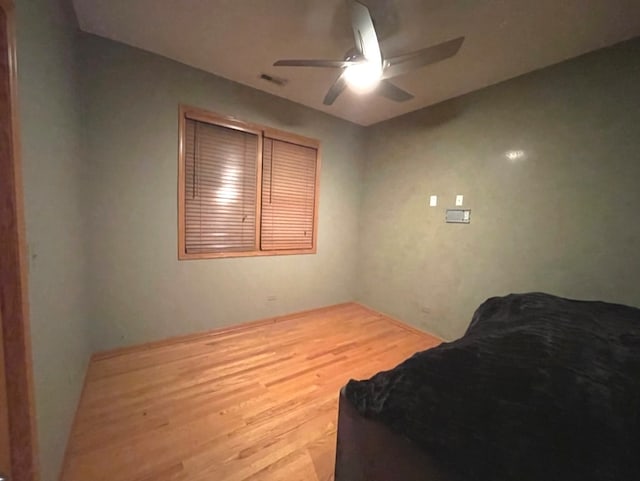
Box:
[74, 0, 640, 125]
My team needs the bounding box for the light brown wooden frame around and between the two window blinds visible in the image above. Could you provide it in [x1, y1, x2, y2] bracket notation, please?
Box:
[178, 105, 321, 260]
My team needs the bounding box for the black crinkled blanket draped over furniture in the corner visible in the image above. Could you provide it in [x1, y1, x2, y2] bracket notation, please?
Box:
[346, 293, 640, 481]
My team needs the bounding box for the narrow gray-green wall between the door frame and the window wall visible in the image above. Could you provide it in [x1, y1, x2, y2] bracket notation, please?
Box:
[17, 0, 91, 481]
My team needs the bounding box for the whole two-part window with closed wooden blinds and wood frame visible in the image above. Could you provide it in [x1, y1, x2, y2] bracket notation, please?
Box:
[178, 107, 320, 259]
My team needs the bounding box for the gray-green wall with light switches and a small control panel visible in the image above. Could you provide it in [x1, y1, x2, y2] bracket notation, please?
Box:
[357, 39, 640, 338]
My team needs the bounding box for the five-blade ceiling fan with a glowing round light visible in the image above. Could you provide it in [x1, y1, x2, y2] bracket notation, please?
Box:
[273, 0, 464, 105]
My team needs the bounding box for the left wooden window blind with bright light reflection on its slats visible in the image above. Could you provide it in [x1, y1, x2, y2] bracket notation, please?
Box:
[184, 119, 258, 253]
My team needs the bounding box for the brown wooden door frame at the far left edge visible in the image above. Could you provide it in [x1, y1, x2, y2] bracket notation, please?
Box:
[0, 0, 38, 481]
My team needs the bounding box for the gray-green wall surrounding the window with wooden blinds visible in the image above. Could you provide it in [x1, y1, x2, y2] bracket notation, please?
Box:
[82, 35, 364, 349]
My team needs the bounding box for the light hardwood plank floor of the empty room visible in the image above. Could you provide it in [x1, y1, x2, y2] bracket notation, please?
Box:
[62, 304, 440, 481]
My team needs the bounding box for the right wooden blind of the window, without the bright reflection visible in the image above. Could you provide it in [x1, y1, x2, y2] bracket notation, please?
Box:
[260, 137, 317, 250]
